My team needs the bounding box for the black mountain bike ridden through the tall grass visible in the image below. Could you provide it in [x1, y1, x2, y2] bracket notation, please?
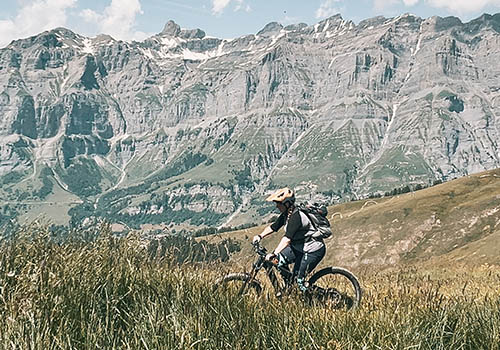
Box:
[213, 242, 362, 309]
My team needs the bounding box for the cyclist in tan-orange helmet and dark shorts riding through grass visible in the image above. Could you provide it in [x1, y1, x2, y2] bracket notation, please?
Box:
[253, 187, 326, 292]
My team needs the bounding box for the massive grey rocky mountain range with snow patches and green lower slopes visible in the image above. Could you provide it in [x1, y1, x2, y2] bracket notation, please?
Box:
[0, 14, 500, 225]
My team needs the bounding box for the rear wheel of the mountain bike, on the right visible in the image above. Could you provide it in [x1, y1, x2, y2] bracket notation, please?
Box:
[308, 267, 362, 310]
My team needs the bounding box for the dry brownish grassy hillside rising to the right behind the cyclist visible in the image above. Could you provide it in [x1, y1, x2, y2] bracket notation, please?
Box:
[208, 169, 500, 268]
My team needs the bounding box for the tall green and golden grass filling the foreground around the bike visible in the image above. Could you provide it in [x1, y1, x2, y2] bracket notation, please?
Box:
[0, 226, 500, 350]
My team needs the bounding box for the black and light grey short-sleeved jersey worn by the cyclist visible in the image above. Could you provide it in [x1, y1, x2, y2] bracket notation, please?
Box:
[271, 208, 325, 253]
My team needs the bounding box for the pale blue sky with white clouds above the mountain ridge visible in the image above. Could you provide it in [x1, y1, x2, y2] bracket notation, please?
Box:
[0, 0, 500, 47]
